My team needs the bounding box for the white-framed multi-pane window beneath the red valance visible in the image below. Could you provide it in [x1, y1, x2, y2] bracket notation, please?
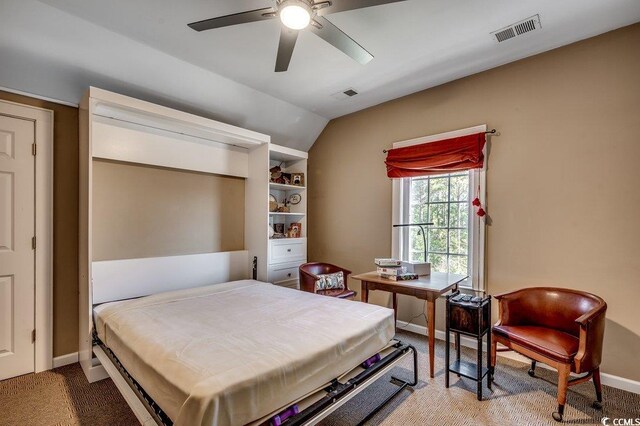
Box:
[393, 125, 485, 290]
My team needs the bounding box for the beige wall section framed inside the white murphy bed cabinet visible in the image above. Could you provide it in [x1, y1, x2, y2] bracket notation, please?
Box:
[93, 161, 244, 260]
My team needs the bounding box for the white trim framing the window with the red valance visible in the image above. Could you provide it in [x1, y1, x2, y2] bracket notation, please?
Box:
[391, 124, 487, 291]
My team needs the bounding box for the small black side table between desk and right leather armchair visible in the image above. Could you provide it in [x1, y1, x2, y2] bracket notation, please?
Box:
[445, 292, 493, 401]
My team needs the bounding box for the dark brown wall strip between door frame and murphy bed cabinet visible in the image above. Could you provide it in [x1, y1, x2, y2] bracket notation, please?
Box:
[0, 91, 78, 356]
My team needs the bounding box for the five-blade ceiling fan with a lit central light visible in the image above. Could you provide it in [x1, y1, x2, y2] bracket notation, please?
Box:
[189, 0, 405, 72]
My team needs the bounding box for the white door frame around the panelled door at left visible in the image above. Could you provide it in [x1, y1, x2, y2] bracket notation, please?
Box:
[0, 100, 53, 373]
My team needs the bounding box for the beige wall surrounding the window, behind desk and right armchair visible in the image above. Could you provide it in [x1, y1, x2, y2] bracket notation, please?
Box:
[309, 24, 640, 380]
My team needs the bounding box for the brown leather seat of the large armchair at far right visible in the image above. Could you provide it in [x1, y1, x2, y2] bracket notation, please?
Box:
[493, 325, 579, 364]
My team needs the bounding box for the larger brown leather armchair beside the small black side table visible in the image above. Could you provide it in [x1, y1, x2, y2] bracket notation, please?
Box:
[491, 287, 607, 421]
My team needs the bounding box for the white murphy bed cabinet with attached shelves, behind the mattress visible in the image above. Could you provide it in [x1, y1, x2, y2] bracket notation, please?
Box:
[79, 87, 307, 382]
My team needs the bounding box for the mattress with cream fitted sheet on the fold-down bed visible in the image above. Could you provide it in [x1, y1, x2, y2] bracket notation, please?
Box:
[94, 280, 395, 426]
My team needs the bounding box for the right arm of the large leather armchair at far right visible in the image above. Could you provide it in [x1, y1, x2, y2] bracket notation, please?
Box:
[574, 303, 607, 373]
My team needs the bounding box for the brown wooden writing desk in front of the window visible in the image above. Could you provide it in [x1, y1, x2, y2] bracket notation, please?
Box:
[351, 272, 467, 377]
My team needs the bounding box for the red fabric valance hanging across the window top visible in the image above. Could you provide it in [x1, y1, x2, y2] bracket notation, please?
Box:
[385, 132, 485, 178]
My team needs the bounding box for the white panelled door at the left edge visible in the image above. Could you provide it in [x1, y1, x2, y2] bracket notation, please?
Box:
[0, 113, 35, 380]
